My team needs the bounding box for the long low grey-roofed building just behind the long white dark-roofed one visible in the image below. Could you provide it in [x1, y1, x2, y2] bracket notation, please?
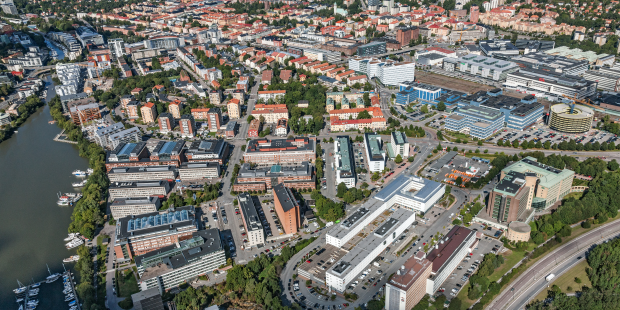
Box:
[510, 52, 590, 75]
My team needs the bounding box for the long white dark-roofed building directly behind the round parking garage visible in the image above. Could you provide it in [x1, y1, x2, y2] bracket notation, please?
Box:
[506, 69, 596, 101]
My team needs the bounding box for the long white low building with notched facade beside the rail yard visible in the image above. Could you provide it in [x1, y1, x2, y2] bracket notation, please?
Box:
[443, 54, 519, 81]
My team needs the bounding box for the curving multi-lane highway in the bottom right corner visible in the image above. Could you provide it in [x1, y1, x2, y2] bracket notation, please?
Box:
[487, 220, 620, 310]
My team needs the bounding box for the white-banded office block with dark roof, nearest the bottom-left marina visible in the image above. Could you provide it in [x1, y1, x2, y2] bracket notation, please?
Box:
[136, 229, 226, 293]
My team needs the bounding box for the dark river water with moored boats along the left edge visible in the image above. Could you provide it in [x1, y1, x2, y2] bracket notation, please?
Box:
[0, 79, 88, 309]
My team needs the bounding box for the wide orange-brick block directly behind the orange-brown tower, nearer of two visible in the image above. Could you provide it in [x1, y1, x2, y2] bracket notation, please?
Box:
[232, 161, 316, 192]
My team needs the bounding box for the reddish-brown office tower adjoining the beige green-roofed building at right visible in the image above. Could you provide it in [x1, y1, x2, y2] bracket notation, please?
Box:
[486, 171, 538, 223]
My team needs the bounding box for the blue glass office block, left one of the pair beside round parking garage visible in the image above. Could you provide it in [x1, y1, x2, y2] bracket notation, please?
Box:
[445, 105, 504, 139]
